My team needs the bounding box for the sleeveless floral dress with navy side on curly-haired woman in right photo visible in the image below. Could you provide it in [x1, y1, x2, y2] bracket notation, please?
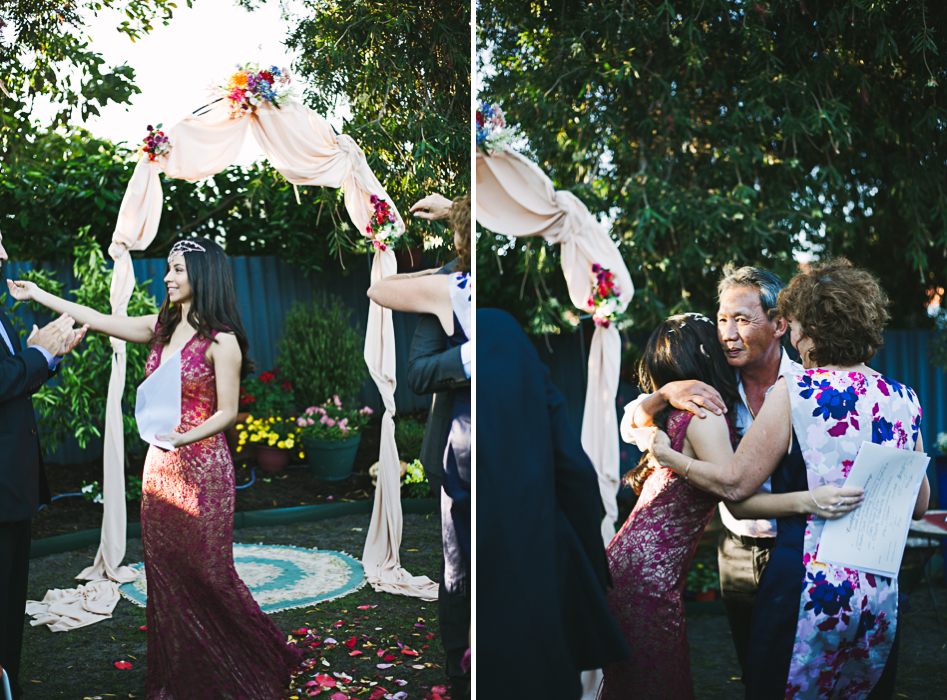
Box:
[746, 369, 921, 700]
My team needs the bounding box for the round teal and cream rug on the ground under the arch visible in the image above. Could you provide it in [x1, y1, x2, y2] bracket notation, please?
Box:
[118, 544, 365, 613]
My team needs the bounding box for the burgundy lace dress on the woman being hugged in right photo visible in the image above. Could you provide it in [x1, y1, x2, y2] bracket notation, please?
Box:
[599, 411, 736, 700]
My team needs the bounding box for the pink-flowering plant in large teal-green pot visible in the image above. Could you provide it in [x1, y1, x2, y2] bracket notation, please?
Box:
[296, 395, 372, 481]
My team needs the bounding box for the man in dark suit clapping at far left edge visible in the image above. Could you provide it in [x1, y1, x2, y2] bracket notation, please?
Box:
[0, 236, 85, 697]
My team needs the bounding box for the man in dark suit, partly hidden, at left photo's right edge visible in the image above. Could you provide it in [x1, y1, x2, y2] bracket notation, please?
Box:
[408, 194, 470, 697]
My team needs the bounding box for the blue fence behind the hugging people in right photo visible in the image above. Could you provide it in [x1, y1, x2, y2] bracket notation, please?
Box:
[533, 330, 947, 498]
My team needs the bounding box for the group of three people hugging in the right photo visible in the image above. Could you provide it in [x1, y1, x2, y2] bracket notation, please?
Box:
[600, 260, 930, 700]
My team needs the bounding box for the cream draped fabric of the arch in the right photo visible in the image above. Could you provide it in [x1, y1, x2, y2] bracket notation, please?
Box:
[477, 149, 635, 544]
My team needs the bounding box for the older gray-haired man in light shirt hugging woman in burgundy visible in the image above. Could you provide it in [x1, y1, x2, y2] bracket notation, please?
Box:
[621, 263, 794, 672]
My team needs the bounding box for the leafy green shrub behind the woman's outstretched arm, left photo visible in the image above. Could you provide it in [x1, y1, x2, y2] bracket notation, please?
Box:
[6, 227, 158, 460]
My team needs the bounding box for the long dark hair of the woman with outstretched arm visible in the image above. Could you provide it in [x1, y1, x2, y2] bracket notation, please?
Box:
[152, 238, 254, 378]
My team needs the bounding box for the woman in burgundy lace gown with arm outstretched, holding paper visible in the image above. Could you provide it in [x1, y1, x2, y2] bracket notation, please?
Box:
[14, 239, 302, 700]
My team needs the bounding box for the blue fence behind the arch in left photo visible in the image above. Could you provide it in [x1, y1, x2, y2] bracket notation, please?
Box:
[4, 257, 431, 464]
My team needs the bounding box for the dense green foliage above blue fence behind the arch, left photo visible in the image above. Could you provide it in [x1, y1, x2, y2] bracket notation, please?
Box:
[0, 129, 351, 271]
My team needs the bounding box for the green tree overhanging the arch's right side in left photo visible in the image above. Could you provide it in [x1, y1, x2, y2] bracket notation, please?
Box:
[287, 0, 470, 256]
